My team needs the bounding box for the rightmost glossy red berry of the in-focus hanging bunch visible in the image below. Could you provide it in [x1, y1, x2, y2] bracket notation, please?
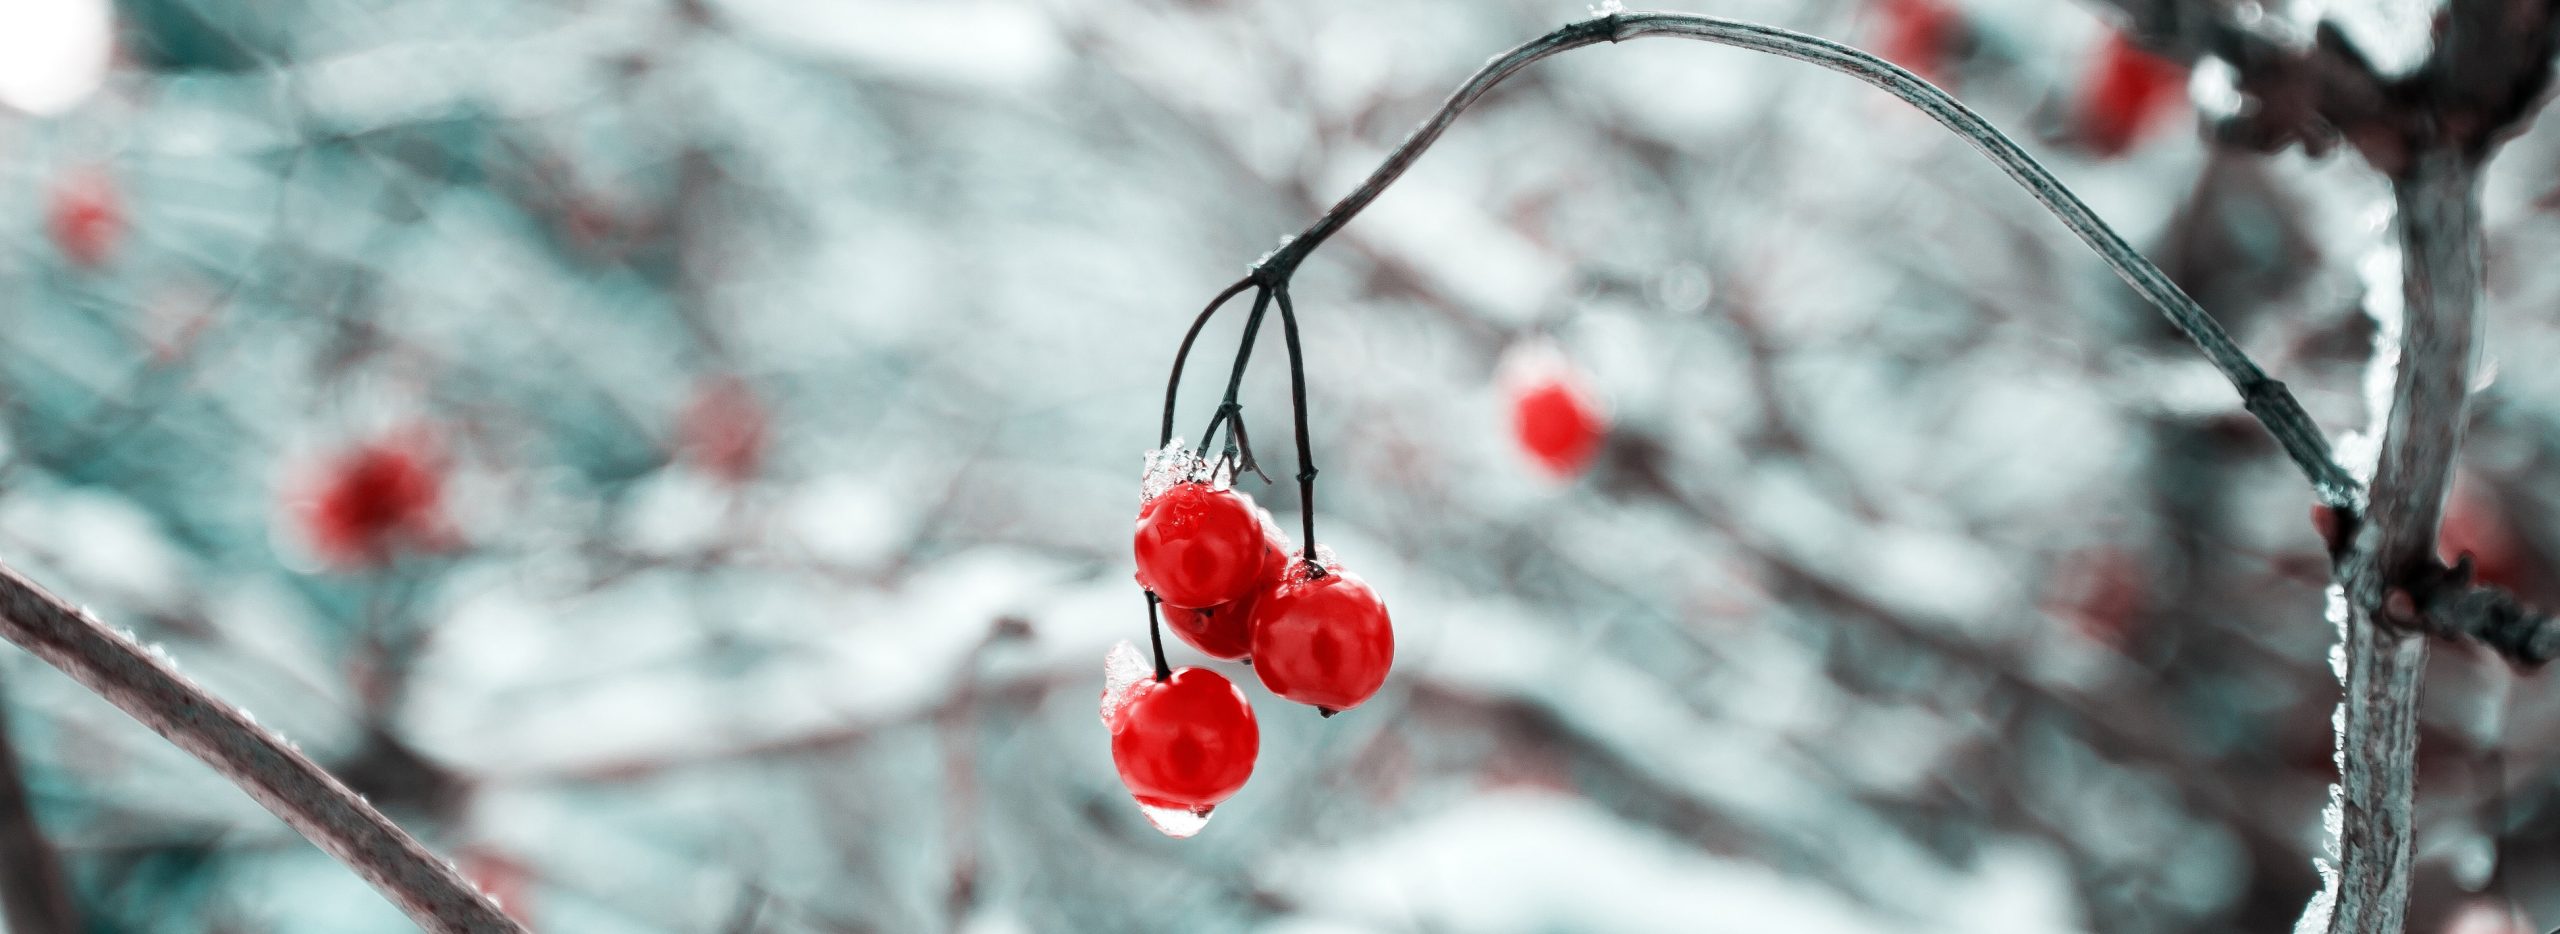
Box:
[1252, 563, 1395, 716]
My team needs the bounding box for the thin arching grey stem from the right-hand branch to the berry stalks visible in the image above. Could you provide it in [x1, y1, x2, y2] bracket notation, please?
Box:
[1254, 13, 2363, 514]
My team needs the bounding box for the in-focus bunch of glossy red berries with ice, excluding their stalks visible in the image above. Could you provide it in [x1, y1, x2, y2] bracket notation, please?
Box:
[1103, 443, 1395, 837]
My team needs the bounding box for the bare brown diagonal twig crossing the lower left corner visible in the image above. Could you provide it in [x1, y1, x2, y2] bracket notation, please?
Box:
[0, 566, 525, 931]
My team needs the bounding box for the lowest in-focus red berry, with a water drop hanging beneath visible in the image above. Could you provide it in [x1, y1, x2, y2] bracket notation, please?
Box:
[1108, 668, 1262, 814]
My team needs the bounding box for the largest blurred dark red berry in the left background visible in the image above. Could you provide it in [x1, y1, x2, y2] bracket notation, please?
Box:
[302, 440, 443, 566]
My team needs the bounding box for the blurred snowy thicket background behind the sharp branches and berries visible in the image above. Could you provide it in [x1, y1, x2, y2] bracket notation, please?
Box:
[0, 0, 2560, 934]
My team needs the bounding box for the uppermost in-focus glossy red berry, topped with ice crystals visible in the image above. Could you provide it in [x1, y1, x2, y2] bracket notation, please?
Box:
[1137, 481, 1267, 609]
